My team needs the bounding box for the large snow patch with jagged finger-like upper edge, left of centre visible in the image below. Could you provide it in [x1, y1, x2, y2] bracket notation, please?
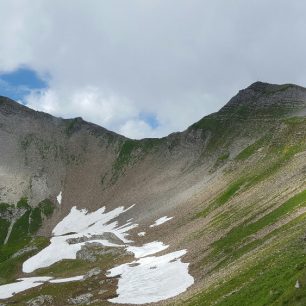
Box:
[22, 207, 137, 273]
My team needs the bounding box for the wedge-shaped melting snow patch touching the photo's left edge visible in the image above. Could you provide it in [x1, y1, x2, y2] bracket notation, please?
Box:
[0, 276, 52, 299]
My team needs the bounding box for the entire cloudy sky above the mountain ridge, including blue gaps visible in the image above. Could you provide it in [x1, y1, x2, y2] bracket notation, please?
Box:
[0, 0, 306, 139]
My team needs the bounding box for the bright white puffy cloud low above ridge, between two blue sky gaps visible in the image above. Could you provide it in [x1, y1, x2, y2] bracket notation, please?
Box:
[25, 86, 138, 130]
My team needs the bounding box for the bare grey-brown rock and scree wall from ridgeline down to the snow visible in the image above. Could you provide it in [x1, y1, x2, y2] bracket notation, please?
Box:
[0, 82, 306, 231]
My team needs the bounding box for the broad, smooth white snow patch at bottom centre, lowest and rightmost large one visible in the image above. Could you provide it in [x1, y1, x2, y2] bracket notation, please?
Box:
[108, 250, 194, 304]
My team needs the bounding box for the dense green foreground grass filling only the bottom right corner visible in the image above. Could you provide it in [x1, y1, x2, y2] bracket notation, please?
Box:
[184, 215, 306, 306]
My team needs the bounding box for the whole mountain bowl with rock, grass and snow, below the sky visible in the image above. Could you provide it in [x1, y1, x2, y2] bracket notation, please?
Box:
[0, 82, 306, 305]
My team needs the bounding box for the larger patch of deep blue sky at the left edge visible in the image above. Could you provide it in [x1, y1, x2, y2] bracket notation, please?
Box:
[0, 67, 47, 102]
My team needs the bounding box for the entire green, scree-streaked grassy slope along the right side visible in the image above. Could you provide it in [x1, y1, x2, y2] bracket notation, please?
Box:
[183, 118, 306, 306]
